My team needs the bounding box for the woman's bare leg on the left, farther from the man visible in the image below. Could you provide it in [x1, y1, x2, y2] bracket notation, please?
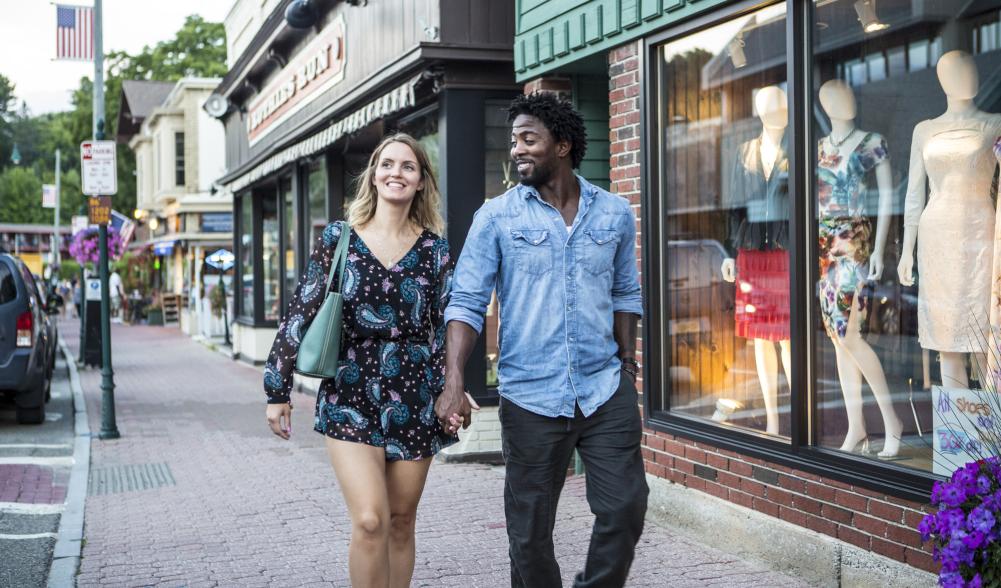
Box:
[326, 437, 389, 588]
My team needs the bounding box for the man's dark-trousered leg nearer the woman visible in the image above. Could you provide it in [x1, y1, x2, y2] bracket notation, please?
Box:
[501, 400, 578, 588]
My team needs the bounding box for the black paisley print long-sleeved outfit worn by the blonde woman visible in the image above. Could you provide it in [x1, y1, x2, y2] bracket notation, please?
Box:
[264, 221, 457, 461]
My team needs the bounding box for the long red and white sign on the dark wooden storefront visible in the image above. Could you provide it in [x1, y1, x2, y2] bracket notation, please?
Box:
[247, 16, 345, 145]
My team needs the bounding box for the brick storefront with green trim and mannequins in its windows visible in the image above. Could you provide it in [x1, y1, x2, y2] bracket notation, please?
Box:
[516, 0, 1001, 583]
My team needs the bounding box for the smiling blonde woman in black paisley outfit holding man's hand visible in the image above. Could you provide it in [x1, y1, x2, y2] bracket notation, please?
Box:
[264, 134, 456, 587]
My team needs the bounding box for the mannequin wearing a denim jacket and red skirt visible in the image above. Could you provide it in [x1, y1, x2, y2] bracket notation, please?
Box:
[720, 86, 792, 435]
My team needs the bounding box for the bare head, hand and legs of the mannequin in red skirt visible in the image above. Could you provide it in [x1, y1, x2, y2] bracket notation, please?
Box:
[720, 86, 792, 435]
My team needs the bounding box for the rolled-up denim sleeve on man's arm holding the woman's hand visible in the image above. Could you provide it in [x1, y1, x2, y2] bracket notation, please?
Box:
[444, 209, 501, 333]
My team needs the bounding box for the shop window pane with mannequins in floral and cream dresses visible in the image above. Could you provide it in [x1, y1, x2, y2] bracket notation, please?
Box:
[809, 0, 1001, 475]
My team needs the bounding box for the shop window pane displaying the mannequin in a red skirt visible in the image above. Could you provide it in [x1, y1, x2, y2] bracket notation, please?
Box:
[650, 3, 792, 439]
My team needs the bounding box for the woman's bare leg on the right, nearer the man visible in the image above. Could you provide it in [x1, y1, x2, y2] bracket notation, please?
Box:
[385, 459, 431, 588]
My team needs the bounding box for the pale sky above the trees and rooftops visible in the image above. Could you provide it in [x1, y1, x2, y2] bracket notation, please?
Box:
[0, 0, 233, 114]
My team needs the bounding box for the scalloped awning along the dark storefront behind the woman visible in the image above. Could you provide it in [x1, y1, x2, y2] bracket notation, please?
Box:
[222, 75, 420, 192]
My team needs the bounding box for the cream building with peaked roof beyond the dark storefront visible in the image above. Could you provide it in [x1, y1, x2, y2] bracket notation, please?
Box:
[118, 78, 233, 337]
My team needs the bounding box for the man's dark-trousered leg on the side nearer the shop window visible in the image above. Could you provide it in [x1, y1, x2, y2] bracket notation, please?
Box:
[574, 376, 650, 588]
